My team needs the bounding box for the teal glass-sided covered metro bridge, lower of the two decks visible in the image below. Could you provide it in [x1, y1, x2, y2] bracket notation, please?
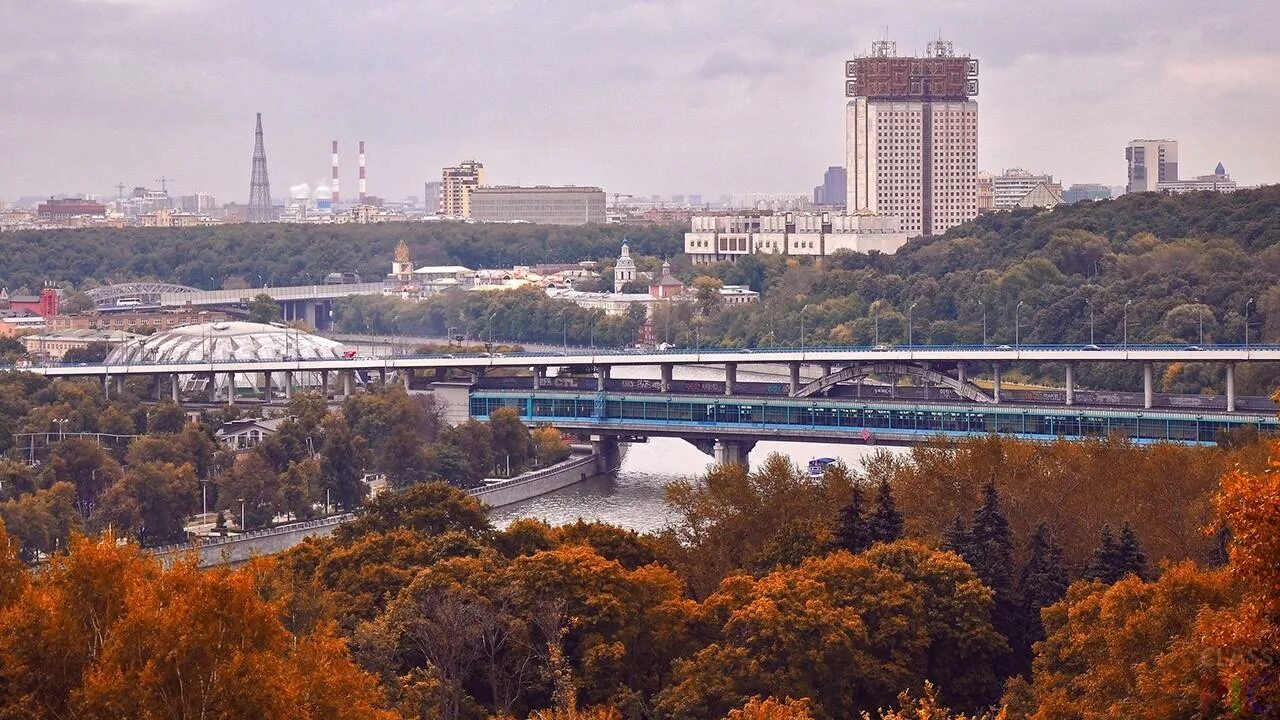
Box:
[468, 388, 1280, 462]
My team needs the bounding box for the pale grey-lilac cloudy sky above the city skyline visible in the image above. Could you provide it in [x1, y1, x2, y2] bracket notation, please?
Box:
[0, 0, 1280, 201]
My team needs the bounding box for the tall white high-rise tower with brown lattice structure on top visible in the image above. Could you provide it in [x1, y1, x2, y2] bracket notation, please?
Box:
[845, 40, 978, 237]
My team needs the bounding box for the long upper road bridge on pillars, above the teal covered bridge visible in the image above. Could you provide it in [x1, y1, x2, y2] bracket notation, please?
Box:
[10, 343, 1280, 413]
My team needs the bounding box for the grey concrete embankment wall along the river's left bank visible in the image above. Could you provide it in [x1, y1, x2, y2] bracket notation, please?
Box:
[150, 454, 607, 568]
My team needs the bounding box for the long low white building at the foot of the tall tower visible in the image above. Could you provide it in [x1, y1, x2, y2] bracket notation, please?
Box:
[685, 213, 908, 265]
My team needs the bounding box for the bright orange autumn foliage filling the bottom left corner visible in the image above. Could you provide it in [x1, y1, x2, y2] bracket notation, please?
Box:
[0, 527, 393, 720]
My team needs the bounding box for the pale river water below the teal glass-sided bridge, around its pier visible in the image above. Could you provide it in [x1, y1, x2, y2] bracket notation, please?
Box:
[489, 430, 902, 532]
